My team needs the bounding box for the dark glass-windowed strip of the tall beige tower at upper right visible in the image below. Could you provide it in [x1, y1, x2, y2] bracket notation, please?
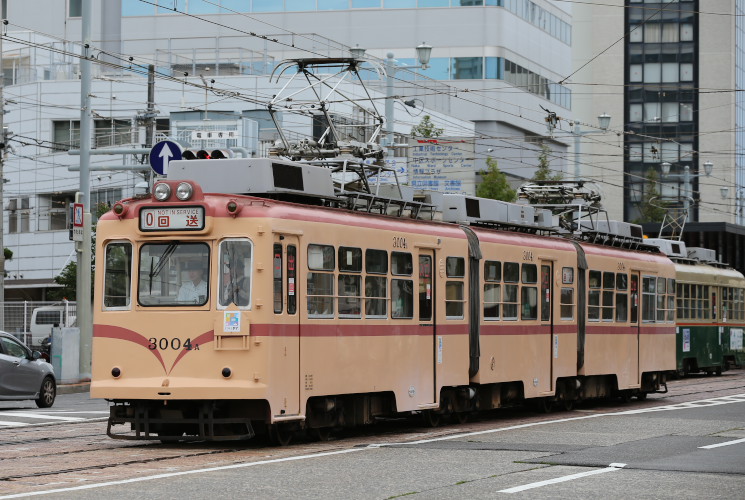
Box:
[624, 0, 704, 221]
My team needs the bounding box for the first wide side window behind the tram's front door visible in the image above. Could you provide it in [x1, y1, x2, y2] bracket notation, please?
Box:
[307, 245, 336, 318]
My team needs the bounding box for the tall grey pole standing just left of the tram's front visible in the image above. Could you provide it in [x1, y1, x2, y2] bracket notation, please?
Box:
[76, 0, 93, 379]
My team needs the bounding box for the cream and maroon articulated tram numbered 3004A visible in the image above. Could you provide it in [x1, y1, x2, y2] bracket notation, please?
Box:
[91, 159, 675, 441]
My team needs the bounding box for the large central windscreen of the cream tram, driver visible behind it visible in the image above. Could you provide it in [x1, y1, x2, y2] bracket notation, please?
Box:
[138, 241, 210, 306]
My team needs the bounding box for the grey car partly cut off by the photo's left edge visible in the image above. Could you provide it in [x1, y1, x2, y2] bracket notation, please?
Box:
[0, 331, 57, 408]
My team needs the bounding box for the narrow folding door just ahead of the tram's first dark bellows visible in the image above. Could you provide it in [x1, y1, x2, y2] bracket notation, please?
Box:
[418, 251, 441, 404]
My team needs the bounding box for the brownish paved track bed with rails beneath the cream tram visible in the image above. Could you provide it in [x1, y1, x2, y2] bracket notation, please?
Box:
[0, 370, 745, 491]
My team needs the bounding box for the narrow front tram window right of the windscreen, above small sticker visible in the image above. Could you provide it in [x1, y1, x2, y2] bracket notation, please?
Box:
[219, 238, 253, 307]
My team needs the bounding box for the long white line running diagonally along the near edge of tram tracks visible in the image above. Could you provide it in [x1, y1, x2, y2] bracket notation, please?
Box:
[0, 394, 745, 500]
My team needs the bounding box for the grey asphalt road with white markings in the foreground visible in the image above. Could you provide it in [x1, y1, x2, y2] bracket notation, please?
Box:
[0, 371, 745, 500]
